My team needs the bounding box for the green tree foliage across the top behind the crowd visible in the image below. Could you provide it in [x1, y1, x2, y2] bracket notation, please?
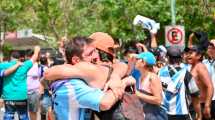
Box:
[0, 0, 215, 47]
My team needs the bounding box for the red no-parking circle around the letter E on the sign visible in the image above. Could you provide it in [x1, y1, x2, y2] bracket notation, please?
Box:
[167, 28, 183, 44]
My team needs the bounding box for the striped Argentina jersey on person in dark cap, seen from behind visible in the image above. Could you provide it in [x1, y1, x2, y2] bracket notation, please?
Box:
[158, 66, 199, 115]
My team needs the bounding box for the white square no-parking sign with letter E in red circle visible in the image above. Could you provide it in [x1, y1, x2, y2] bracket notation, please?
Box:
[165, 25, 185, 47]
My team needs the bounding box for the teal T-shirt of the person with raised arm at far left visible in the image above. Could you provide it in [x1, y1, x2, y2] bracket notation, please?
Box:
[0, 60, 33, 100]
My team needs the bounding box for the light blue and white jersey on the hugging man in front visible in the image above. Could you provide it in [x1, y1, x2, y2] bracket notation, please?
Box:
[53, 79, 104, 120]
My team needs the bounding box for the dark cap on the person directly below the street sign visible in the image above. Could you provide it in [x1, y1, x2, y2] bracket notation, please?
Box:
[167, 46, 182, 57]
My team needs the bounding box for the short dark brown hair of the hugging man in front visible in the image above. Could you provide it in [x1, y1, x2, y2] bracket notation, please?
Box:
[65, 36, 92, 64]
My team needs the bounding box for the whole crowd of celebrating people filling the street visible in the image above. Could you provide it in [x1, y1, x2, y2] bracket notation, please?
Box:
[0, 29, 215, 120]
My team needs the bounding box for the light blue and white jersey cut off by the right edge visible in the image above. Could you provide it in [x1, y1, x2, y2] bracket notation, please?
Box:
[203, 59, 215, 100]
